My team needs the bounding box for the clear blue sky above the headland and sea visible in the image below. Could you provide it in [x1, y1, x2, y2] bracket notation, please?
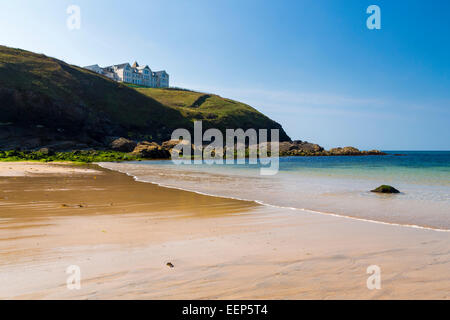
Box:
[0, 0, 450, 150]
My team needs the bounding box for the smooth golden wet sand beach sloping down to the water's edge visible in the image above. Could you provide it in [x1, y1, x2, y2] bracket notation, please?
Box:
[0, 163, 450, 299]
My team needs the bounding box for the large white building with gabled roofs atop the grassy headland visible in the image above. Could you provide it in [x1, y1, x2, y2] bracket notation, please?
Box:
[84, 62, 169, 88]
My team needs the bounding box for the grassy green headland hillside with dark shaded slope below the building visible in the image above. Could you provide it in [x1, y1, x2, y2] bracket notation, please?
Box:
[0, 46, 290, 149]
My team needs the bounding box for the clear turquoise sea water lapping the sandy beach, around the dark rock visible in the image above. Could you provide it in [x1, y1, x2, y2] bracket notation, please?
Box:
[98, 151, 450, 230]
